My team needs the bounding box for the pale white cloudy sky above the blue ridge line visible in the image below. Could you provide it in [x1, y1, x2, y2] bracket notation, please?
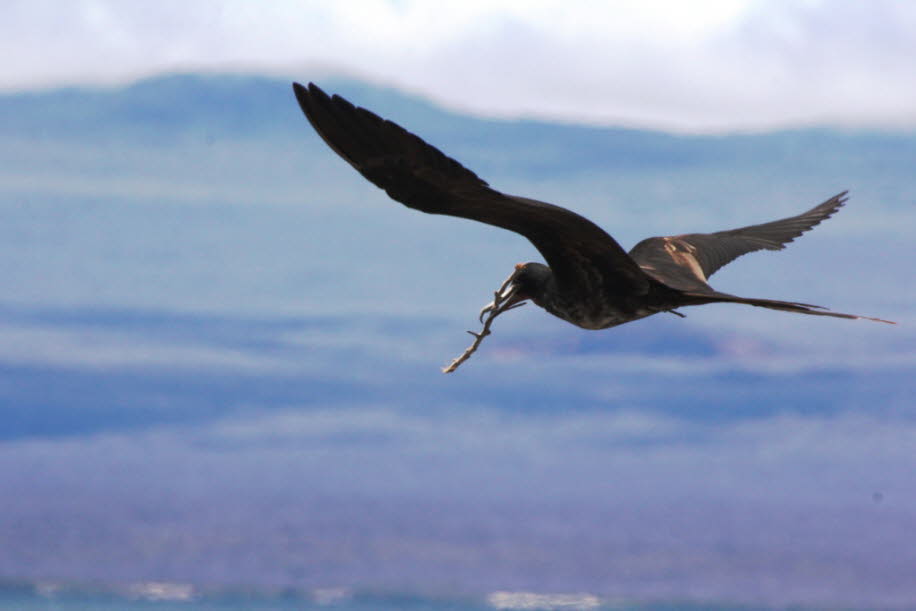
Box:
[0, 0, 916, 132]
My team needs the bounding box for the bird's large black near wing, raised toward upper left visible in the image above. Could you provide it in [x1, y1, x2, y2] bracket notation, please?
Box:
[293, 83, 650, 294]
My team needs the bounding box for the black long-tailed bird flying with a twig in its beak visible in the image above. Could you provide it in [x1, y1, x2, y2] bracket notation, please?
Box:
[293, 83, 890, 329]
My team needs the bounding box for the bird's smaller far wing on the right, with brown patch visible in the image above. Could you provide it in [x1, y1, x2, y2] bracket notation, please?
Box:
[630, 191, 847, 290]
